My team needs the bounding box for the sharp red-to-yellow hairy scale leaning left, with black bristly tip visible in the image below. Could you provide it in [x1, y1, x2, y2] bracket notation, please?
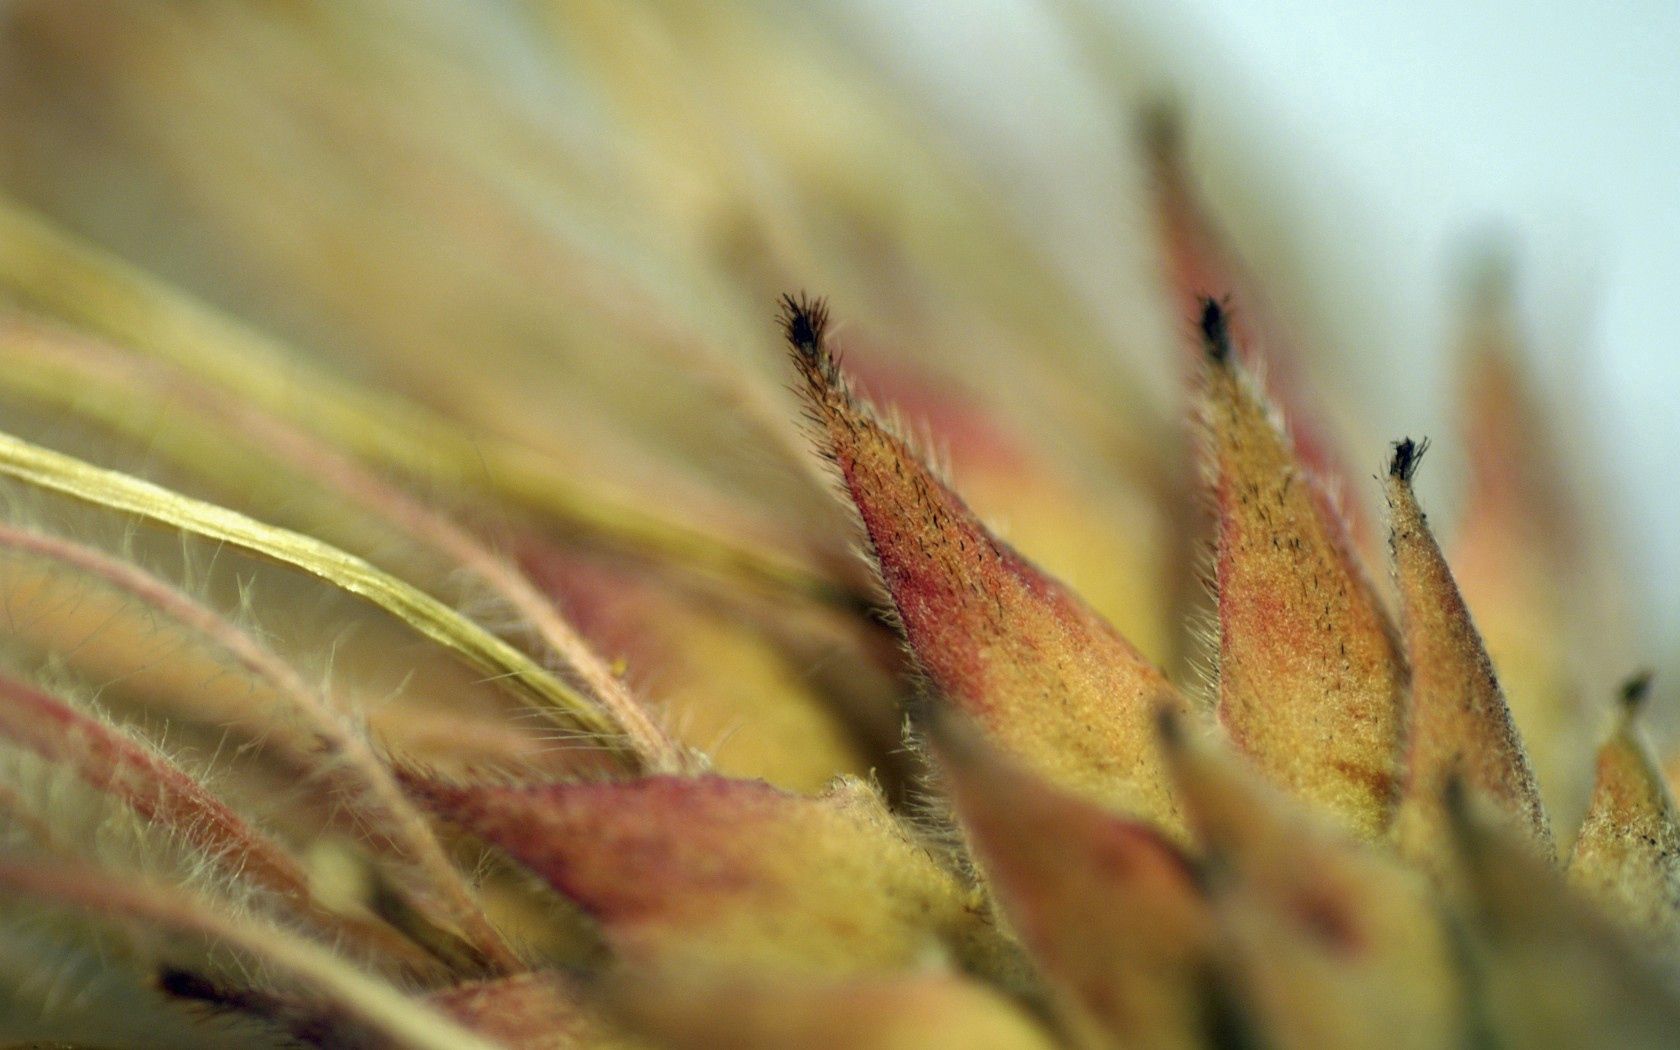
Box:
[788, 302, 1183, 828]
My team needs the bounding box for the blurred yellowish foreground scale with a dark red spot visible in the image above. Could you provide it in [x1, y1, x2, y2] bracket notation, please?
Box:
[1163, 717, 1467, 1050]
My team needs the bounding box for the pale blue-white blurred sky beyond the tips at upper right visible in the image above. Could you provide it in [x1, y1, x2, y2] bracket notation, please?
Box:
[845, 0, 1680, 637]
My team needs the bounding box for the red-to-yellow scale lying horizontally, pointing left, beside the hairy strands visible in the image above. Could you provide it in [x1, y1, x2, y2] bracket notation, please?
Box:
[410, 776, 991, 973]
